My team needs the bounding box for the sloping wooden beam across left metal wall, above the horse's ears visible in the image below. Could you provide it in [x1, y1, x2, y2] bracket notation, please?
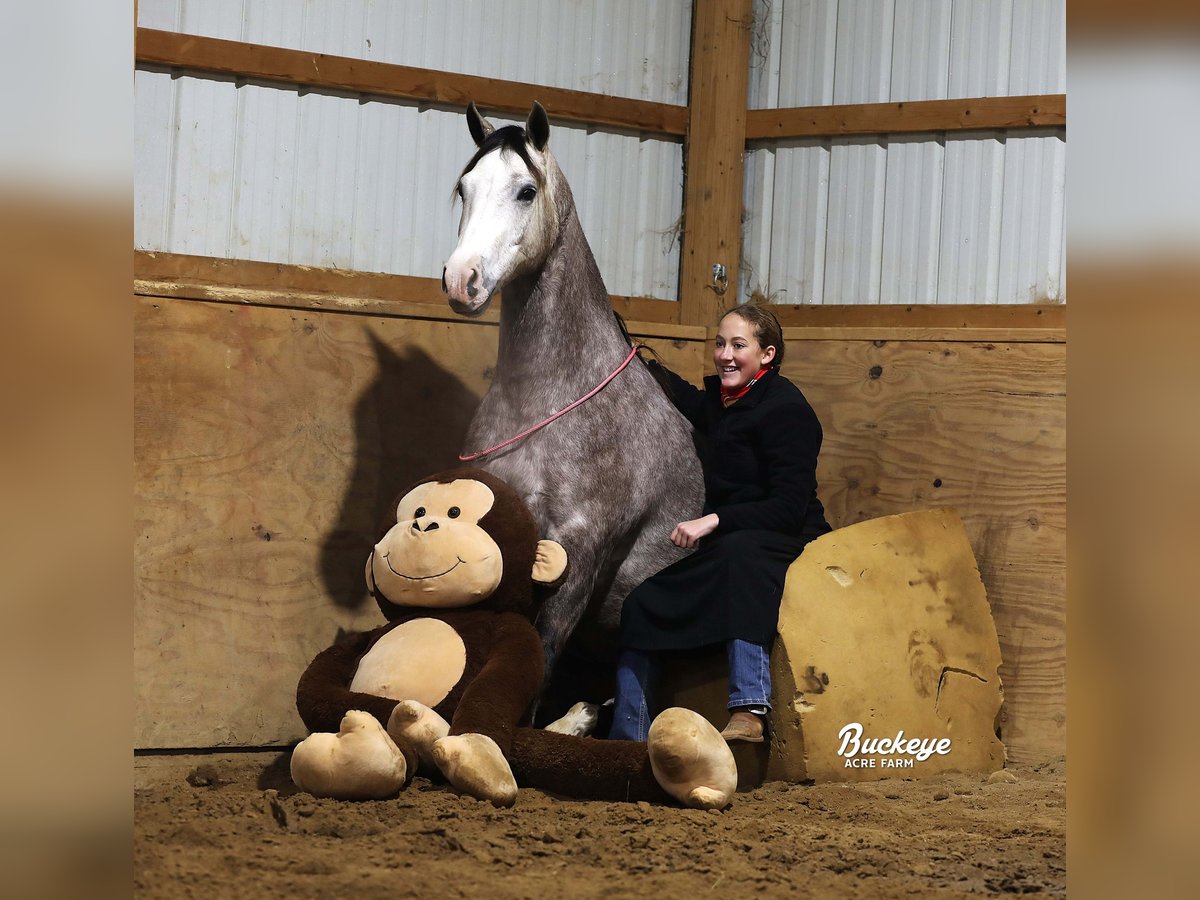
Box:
[136, 28, 688, 139]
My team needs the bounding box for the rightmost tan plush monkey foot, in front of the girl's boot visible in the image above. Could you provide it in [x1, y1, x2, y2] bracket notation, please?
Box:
[647, 707, 738, 809]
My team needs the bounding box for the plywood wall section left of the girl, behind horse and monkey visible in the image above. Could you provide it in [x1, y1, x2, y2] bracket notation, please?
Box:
[134, 296, 703, 749]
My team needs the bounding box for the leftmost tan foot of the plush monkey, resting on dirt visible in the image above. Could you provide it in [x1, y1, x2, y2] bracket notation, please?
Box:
[292, 709, 408, 800]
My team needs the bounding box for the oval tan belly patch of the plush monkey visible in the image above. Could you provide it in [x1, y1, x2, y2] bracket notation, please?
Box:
[350, 619, 467, 708]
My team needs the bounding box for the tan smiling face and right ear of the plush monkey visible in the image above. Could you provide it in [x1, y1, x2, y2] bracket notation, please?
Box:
[366, 473, 566, 608]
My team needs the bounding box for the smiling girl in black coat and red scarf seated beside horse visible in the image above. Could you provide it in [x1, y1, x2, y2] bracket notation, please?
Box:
[610, 304, 829, 742]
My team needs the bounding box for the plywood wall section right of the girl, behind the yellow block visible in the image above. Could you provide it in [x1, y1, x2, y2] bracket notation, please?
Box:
[784, 329, 1067, 762]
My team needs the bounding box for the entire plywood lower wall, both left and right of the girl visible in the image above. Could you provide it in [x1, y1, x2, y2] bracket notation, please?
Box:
[133, 295, 1066, 762]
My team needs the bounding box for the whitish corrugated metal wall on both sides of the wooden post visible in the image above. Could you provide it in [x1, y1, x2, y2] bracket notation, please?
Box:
[134, 0, 1066, 304]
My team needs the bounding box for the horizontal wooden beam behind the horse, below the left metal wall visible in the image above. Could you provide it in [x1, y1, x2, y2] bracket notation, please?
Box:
[133, 250, 686, 324]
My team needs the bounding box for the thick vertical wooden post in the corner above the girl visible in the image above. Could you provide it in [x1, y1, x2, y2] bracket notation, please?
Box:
[679, 0, 754, 325]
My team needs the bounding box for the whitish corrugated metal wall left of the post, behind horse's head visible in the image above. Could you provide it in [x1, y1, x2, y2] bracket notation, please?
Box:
[134, 0, 691, 299]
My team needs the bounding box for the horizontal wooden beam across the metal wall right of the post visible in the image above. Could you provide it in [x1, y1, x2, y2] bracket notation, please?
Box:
[745, 94, 1067, 140]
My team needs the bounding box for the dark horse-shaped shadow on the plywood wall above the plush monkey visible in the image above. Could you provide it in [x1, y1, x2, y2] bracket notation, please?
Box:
[320, 330, 480, 610]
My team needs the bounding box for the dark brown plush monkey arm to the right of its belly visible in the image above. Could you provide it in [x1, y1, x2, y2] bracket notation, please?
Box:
[450, 612, 545, 754]
